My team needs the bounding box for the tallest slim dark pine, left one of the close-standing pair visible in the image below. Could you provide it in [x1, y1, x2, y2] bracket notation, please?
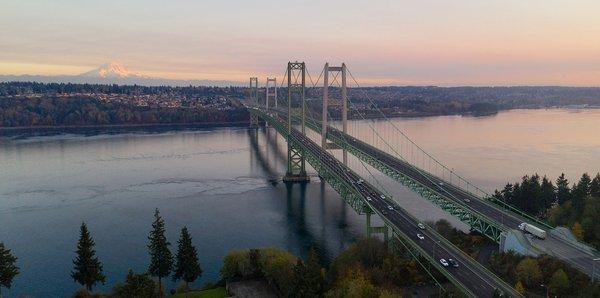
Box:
[148, 208, 173, 296]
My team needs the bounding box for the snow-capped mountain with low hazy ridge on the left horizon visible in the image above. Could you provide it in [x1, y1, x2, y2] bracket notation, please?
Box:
[0, 62, 239, 87]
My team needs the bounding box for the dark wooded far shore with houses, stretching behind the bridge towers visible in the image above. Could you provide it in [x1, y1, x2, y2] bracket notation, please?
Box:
[0, 82, 600, 129]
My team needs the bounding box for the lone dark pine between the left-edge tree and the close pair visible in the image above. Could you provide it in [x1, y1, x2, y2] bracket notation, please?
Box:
[71, 222, 106, 291]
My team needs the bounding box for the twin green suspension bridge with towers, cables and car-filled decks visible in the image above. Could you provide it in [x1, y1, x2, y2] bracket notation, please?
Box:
[245, 62, 598, 297]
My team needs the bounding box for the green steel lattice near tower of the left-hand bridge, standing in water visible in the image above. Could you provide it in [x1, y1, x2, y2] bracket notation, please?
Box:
[276, 61, 310, 182]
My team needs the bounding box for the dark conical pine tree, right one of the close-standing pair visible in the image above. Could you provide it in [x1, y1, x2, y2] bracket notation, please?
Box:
[173, 227, 202, 289]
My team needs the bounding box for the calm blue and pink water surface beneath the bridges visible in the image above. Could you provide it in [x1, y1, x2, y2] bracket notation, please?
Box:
[0, 110, 600, 297]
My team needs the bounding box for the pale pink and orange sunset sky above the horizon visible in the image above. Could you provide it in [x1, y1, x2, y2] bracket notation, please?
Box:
[0, 0, 600, 86]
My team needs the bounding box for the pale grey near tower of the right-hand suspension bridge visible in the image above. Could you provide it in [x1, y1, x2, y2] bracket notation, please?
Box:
[321, 63, 348, 165]
